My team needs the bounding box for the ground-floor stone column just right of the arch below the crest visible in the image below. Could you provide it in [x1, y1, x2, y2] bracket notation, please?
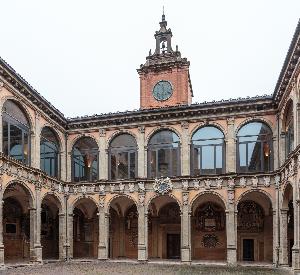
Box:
[181, 191, 191, 263]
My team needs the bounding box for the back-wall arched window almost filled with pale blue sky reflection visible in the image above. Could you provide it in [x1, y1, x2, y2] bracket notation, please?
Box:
[191, 126, 225, 176]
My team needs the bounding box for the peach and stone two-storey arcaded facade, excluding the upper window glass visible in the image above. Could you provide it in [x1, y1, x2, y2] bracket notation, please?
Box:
[0, 12, 300, 270]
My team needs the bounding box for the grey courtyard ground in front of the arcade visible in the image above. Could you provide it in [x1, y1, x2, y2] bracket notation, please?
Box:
[0, 262, 289, 275]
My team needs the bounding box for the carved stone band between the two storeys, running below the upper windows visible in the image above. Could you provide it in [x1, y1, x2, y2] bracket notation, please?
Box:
[0, 145, 300, 195]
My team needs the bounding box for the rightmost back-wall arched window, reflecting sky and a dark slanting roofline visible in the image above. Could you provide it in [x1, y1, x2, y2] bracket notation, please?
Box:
[237, 122, 273, 172]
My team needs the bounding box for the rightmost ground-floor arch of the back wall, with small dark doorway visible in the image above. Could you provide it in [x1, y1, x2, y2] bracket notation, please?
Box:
[236, 189, 275, 262]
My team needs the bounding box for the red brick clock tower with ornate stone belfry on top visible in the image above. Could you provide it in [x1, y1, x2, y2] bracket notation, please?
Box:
[137, 14, 193, 109]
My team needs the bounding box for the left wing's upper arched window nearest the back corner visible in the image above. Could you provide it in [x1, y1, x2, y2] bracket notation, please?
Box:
[40, 127, 59, 177]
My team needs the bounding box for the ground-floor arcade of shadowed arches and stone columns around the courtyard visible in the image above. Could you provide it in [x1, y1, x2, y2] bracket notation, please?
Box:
[0, 181, 298, 272]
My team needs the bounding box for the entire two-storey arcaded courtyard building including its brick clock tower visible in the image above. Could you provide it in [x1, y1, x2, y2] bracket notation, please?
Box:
[0, 12, 300, 271]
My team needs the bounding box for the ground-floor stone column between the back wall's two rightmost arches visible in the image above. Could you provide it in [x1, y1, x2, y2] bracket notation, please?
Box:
[225, 189, 237, 266]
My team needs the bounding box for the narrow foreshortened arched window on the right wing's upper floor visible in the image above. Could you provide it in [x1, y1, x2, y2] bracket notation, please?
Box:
[284, 101, 294, 157]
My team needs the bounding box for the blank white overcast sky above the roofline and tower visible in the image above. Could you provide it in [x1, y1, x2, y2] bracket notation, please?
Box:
[0, 0, 300, 117]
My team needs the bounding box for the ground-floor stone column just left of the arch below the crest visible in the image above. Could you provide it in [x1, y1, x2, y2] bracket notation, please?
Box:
[137, 193, 148, 261]
